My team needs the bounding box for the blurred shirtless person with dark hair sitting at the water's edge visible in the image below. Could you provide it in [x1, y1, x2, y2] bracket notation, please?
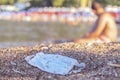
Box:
[74, 0, 118, 43]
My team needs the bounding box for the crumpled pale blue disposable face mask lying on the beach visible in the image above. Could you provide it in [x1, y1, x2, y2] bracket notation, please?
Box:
[25, 52, 85, 75]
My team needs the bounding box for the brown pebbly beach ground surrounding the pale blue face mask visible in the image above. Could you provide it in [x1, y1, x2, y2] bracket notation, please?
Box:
[0, 43, 120, 80]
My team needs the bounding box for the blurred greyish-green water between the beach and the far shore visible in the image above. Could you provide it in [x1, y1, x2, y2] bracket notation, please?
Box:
[0, 20, 120, 47]
